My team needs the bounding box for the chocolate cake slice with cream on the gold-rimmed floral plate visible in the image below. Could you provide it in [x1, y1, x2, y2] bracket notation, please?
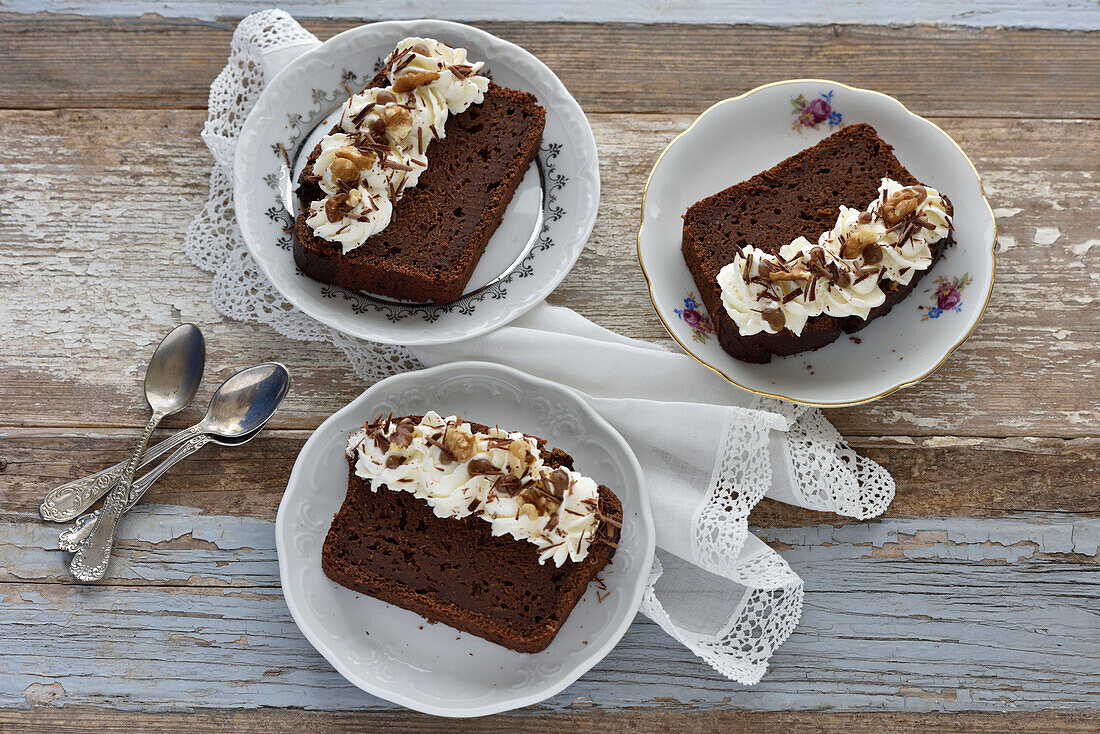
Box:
[681, 124, 954, 362]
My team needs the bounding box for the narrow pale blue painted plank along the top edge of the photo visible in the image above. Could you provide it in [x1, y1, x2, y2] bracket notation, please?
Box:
[0, 0, 1100, 31]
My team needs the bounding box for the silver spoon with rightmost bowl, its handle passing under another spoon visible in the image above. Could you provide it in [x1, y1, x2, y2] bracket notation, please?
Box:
[58, 362, 290, 552]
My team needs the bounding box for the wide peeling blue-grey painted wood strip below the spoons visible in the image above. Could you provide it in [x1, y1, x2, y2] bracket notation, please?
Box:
[0, 505, 1100, 711]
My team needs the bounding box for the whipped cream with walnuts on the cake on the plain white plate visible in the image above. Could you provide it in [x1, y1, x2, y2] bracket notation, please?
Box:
[348, 412, 617, 567]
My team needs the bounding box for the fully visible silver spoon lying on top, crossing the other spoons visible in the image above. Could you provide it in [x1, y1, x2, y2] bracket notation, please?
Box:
[69, 324, 206, 581]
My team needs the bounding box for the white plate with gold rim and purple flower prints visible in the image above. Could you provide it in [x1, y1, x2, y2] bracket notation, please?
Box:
[638, 79, 997, 406]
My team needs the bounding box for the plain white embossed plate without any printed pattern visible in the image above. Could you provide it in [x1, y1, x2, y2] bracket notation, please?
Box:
[275, 362, 653, 716]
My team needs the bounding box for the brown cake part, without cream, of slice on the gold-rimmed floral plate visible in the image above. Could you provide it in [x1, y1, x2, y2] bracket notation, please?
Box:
[681, 123, 954, 362]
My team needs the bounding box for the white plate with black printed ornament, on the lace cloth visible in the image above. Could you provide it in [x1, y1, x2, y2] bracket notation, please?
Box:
[233, 20, 600, 344]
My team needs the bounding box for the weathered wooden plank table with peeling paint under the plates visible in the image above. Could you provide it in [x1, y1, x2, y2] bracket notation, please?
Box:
[0, 1, 1100, 732]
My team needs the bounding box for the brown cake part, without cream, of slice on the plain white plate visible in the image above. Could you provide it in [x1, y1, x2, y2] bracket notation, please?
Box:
[321, 418, 623, 653]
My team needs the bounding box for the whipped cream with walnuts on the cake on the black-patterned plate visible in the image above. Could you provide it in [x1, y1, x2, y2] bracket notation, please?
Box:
[306, 37, 488, 253]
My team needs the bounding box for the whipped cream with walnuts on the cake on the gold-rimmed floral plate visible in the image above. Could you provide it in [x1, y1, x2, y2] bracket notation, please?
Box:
[718, 178, 952, 337]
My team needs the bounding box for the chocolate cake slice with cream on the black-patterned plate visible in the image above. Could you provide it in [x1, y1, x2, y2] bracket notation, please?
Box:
[294, 39, 546, 303]
